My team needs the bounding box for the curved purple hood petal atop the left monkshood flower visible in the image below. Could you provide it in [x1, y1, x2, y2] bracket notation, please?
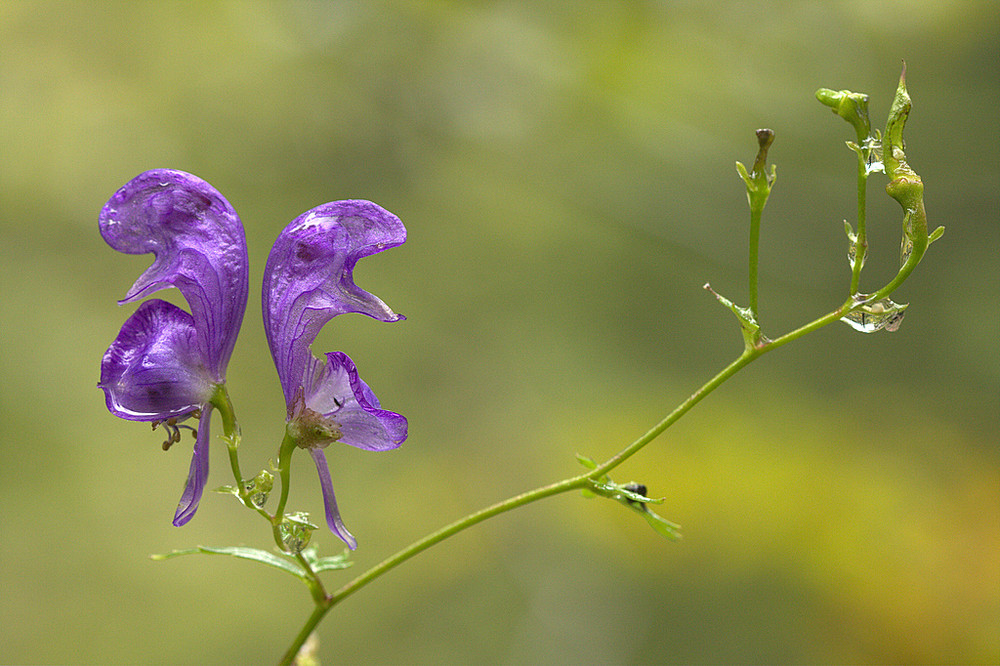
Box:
[99, 169, 249, 381]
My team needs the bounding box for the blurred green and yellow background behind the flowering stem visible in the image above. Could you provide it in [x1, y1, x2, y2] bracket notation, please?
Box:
[0, 0, 1000, 664]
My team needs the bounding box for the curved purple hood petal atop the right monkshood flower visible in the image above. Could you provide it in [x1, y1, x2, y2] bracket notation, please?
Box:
[263, 201, 406, 407]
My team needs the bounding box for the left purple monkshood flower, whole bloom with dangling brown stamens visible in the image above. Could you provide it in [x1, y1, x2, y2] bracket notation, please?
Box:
[98, 169, 249, 526]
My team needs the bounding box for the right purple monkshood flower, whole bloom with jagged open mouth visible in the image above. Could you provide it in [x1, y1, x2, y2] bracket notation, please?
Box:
[263, 201, 407, 549]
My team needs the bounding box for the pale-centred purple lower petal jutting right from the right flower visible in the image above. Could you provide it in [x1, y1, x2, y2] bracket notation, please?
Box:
[304, 352, 407, 451]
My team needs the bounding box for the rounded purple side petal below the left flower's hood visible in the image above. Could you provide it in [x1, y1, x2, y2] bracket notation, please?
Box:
[98, 299, 214, 421]
